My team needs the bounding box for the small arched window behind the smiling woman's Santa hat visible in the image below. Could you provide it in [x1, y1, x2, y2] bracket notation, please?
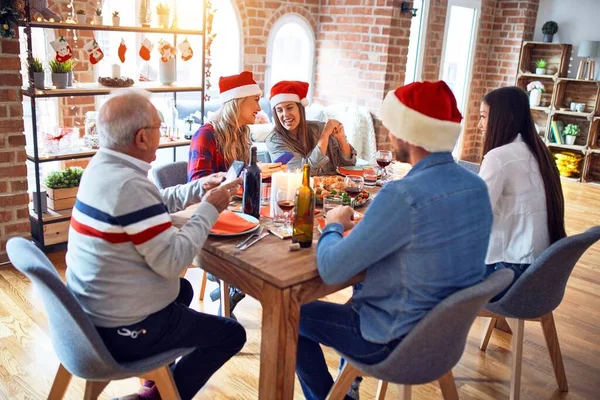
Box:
[269, 22, 313, 90]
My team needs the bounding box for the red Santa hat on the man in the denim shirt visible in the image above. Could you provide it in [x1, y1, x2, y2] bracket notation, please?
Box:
[379, 81, 462, 153]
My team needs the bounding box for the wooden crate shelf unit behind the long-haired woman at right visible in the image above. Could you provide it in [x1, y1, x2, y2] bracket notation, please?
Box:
[515, 41, 600, 184]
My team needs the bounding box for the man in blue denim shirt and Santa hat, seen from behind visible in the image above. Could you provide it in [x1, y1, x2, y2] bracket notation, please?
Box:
[296, 81, 492, 400]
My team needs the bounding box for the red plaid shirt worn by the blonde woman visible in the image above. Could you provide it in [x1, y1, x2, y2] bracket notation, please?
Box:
[188, 123, 227, 182]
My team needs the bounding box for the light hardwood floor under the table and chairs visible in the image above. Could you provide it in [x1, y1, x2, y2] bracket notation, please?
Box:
[0, 181, 600, 400]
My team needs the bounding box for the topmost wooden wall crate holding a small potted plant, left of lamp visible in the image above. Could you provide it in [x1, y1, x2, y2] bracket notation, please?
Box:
[519, 42, 572, 78]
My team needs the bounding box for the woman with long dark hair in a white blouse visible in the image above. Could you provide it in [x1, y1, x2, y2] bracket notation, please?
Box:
[478, 87, 566, 297]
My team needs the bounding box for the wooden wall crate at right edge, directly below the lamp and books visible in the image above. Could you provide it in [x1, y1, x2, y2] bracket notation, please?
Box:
[552, 78, 600, 117]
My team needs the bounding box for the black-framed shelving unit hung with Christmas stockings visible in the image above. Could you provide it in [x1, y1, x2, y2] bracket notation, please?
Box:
[20, 0, 210, 250]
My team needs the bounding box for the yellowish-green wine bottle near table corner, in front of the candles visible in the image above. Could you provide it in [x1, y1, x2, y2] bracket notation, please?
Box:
[292, 164, 315, 247]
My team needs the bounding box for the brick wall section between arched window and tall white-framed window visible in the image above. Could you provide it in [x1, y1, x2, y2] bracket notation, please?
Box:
[315, 0, 411, 148]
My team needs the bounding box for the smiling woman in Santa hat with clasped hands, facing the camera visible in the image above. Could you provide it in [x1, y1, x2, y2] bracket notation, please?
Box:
[266, 81, 356, 175]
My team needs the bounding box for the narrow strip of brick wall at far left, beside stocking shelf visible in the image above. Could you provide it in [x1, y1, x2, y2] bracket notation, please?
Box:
[0, 39, 29, 262]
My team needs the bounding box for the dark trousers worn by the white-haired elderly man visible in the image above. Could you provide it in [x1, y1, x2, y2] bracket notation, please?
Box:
[96, 278, 246, 400]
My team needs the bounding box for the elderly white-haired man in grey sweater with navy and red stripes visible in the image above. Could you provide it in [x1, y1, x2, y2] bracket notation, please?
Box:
[67, 89, 246, 399]
